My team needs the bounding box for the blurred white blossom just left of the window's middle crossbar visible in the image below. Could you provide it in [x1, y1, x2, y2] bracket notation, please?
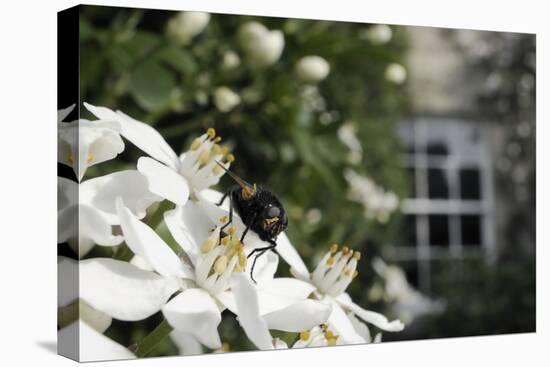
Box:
[344, 169, 399, 223]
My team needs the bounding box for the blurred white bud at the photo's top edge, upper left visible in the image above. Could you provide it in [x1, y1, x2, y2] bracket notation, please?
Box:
[166, 11, 210, 45]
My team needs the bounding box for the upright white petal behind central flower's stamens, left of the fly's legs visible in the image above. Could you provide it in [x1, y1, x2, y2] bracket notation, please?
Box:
[164, 201, 213, 265]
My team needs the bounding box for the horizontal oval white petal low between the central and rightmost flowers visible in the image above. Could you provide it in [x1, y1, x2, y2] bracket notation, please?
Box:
[264, 299, 331, 332]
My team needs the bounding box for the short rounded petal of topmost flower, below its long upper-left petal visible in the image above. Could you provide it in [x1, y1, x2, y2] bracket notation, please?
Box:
[137, 157, 189, 205]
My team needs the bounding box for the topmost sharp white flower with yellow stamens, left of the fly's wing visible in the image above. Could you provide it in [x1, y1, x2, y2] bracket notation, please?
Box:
[84, 103, 234, 205]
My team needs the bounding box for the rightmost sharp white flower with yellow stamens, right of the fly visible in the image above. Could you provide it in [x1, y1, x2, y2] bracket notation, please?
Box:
[290, 245, 404, 344]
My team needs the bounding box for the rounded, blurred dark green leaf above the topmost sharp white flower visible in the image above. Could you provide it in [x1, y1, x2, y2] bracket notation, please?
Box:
[129, 61, 176, 112]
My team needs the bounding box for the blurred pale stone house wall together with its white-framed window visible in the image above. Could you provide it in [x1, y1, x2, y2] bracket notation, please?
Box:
[386, 27, 534, 293]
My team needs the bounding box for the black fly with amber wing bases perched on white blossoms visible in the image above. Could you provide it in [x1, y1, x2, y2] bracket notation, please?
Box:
[216, 162, 288, 283]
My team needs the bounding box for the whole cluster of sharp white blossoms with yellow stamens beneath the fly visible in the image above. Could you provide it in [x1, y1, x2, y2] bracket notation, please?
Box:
[58, 103, 403, 360]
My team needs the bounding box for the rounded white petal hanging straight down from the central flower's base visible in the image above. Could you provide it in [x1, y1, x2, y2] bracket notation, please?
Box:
[162, 288, 222, 349]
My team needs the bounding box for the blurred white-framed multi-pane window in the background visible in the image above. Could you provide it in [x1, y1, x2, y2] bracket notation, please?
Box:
[390, 118, 495, 292]
